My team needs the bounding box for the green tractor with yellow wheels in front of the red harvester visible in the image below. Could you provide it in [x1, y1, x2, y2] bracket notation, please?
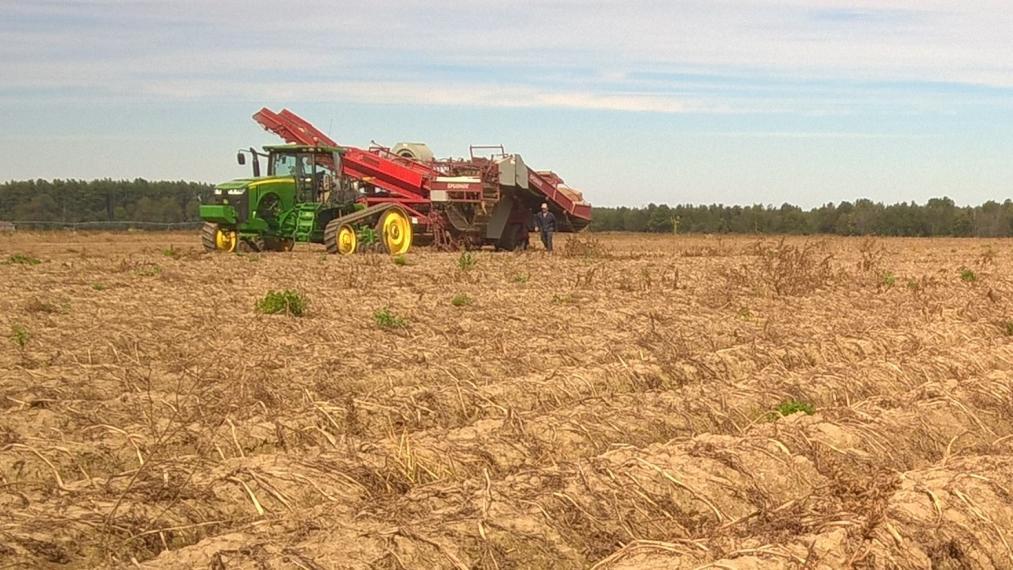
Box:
[200, 145, 412, 255]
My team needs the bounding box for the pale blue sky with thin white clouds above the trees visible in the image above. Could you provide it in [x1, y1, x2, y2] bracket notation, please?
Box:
[0, 0, 1013, 207]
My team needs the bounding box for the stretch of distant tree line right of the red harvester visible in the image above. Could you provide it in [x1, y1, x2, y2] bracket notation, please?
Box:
[591, 197, 1013, 237]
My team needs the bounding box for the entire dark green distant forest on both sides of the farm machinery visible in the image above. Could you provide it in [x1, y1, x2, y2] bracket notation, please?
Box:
[0, 178, 1013, 237]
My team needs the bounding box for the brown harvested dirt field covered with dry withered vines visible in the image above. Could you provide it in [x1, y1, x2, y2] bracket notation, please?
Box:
[0, 233, 1013, 570]
